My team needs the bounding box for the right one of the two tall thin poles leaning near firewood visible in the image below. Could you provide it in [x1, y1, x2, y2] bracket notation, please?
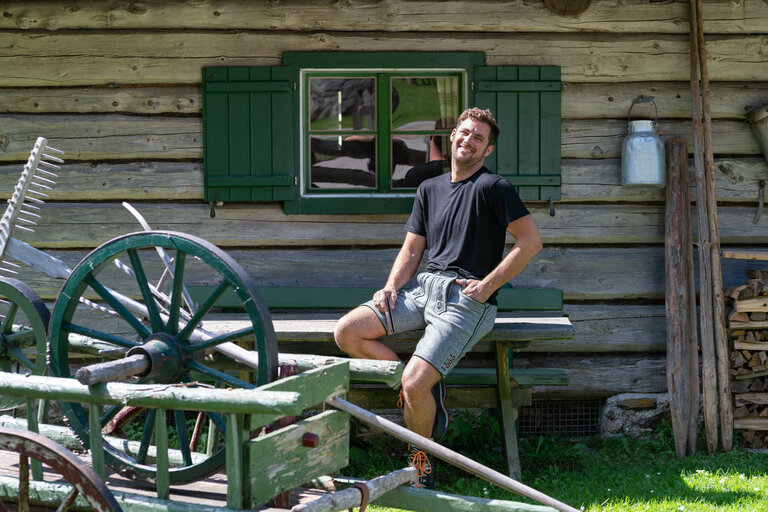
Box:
[696, 0, 733, 452]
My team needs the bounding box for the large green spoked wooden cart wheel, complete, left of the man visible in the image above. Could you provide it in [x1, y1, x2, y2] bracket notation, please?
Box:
[48, 231, 277, 484]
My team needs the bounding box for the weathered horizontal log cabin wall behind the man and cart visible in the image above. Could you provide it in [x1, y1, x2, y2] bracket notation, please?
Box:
[0, 0, 768, 397]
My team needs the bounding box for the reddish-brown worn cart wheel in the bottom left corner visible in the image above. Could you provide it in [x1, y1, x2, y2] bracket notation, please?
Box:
[0, 428, 122, 512]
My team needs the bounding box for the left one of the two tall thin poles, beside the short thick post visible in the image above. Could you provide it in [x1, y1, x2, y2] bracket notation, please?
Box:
[690, 0, 718, 453]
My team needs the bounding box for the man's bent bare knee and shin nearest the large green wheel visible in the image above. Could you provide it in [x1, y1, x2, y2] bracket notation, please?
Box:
[333, 306, 400, 361]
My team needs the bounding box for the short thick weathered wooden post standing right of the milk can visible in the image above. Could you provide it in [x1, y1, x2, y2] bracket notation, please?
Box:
[664, 137, 691, 458]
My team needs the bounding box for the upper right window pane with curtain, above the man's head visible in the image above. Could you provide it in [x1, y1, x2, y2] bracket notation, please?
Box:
[391, 76, 459, 131]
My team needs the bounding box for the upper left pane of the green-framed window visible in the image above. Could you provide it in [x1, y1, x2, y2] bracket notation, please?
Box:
[309, 78, 376, 131]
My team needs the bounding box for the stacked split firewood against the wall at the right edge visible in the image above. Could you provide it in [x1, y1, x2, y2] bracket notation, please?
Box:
[726, 269, 768, 449]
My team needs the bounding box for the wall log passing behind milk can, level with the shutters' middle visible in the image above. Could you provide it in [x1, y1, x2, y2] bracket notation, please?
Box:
[0, 115, 756, 163]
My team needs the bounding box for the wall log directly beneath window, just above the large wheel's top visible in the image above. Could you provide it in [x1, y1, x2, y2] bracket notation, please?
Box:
[4, 202, 768, 249]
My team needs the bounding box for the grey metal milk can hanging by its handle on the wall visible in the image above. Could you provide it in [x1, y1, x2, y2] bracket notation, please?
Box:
[621, 95, 666, 187]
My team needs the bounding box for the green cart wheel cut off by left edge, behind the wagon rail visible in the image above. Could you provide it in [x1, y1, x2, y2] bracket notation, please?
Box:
[0, 277, 51, 410]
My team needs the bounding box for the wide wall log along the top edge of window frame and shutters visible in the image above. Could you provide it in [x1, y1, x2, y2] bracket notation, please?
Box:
[0, 32, 768, 87]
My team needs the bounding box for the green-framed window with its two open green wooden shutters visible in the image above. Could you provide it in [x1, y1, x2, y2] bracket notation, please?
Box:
[203, 52, 560, 213]
